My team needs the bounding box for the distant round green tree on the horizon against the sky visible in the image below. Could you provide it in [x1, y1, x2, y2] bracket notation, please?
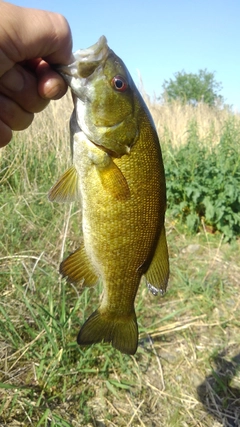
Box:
[163, 69, 223, 106]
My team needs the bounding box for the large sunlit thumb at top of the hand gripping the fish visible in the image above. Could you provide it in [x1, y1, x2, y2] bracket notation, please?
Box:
[0, 2, 72, 75]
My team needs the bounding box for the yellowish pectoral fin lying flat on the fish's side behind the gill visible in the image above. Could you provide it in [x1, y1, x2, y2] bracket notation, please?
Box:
[96, 157, 130, 200]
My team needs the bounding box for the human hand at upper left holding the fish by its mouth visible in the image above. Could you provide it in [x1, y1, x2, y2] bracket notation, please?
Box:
[0, 0, 72, 147]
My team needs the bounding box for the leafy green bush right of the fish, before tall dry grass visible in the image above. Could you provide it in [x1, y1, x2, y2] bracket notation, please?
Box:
[164, 116, 240, 241]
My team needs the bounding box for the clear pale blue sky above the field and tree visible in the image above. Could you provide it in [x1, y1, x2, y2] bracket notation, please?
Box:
[12, 0, 240, 112]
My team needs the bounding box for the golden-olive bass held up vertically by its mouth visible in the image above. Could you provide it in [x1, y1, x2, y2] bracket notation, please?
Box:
[48, 36, 169, 355]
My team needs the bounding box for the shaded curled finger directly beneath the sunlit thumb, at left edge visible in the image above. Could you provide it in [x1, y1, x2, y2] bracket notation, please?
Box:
[0, 64, 49, 113]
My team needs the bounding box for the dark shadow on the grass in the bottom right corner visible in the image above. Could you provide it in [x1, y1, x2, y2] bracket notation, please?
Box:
[197, 350, 240, 427]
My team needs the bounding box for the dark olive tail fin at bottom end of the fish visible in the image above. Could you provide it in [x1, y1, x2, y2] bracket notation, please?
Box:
[77, 310, 138, 354]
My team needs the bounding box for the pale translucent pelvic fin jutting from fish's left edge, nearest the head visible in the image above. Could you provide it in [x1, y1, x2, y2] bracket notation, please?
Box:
[48, 166, 79, 203]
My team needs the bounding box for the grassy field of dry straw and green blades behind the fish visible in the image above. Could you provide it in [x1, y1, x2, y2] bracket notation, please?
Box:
[0, 97, 240, 427]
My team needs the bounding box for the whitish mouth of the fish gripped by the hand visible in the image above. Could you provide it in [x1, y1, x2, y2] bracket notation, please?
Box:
[55, 36, 109, 80]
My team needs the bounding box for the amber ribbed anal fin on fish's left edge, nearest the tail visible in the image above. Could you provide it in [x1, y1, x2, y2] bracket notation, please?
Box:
[60, 246, 99, 287]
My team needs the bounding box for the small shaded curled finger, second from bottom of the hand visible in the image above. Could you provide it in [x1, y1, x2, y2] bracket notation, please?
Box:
[0, 94, 34, 132]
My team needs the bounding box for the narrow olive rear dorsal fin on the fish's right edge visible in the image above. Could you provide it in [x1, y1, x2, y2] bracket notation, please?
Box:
[144, 227, 169, 295]
